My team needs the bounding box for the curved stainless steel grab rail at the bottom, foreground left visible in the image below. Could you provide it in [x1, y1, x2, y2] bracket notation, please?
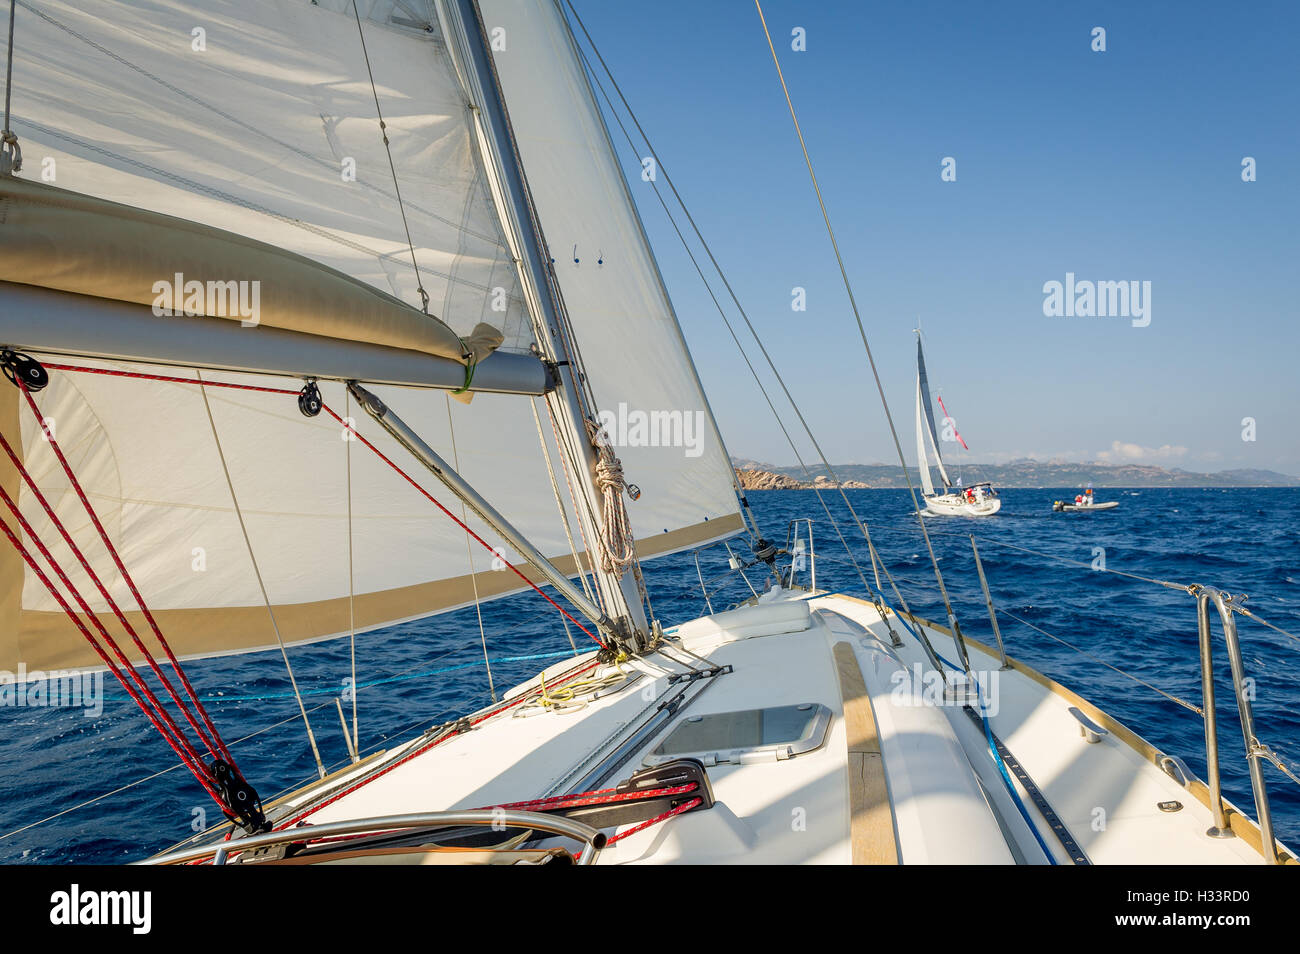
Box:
[137, 808, 606, 866]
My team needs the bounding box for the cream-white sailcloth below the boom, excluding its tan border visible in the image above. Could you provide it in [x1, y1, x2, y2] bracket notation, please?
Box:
[5, 361, 568, 610]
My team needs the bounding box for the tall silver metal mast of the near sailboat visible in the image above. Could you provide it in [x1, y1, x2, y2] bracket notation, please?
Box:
[437, 0, 650, 649]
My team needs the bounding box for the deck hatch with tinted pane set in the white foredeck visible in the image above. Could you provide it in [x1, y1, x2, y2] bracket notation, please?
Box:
[645, 702, 831, 766]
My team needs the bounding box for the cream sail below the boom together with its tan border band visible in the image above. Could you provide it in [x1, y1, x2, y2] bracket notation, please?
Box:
[0, 361, 740, 671]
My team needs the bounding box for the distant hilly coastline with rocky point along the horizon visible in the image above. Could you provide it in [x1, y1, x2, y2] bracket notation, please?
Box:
[732, 458, 1300, 490]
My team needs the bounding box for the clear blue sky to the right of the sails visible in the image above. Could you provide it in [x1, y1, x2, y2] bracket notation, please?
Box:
[575, 0, 1300, 474]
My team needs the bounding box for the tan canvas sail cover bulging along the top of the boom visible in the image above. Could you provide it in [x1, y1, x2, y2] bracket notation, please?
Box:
[0, 177, 501, 361]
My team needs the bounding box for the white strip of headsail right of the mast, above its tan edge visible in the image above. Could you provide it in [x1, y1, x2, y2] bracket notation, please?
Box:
[480, 0, 738, 539]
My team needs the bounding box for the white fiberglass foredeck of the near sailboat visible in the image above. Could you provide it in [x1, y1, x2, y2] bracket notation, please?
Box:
[236, 593, 1289, 864]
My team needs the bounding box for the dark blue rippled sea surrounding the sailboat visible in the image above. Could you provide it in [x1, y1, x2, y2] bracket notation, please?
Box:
[0, 489, 1300, 863]
